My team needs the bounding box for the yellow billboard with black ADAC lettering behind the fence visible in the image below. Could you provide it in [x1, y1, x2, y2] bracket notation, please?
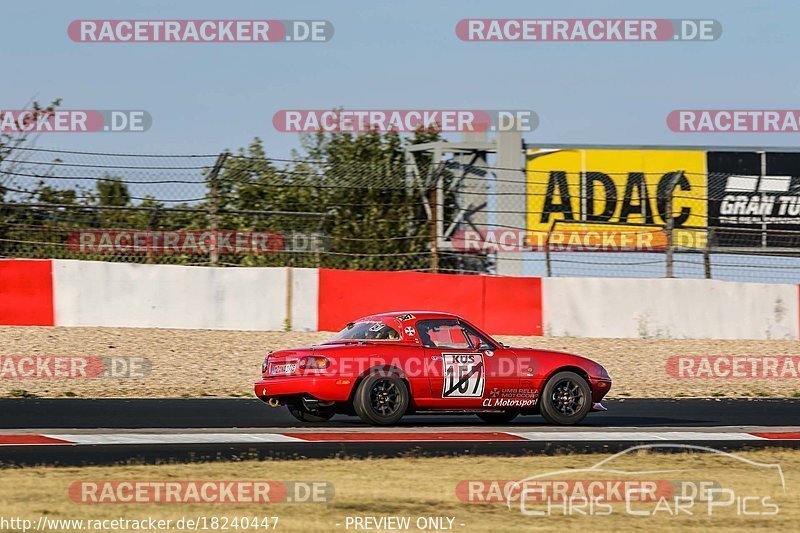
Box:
[527, 149, 708, 248]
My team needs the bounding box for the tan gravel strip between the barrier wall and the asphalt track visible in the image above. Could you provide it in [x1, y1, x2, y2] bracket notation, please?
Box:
[0, 327, 800, 397]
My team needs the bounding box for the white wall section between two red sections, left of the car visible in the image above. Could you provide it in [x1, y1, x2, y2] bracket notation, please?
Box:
[53, 260, 286, 330]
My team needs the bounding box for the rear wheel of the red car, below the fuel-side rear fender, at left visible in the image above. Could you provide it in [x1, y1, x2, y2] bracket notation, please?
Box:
[353, 376, 411, 426]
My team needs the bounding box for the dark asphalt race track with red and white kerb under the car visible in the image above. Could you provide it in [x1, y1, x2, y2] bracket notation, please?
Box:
[0, 398, 800, 465]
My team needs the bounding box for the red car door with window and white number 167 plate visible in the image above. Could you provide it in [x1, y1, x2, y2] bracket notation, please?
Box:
[417, 319, 518, 409]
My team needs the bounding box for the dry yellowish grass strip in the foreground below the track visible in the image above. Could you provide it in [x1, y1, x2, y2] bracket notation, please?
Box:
[0, 449, 800, 532]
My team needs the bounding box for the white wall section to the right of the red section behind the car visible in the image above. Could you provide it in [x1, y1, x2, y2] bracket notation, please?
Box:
[542, 278, 800, 339]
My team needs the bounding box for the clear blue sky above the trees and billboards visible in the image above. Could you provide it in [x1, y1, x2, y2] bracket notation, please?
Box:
[0, 0, 800, 157]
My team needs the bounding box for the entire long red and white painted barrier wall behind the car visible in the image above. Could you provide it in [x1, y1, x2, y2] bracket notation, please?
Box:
[0, 259, 800, 339]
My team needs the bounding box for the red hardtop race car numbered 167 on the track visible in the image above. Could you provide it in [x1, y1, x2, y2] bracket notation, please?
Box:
[255, 311, 611, 425]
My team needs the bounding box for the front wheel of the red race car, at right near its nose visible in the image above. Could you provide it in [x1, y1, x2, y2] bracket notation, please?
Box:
[539, 371, 592, 426]
